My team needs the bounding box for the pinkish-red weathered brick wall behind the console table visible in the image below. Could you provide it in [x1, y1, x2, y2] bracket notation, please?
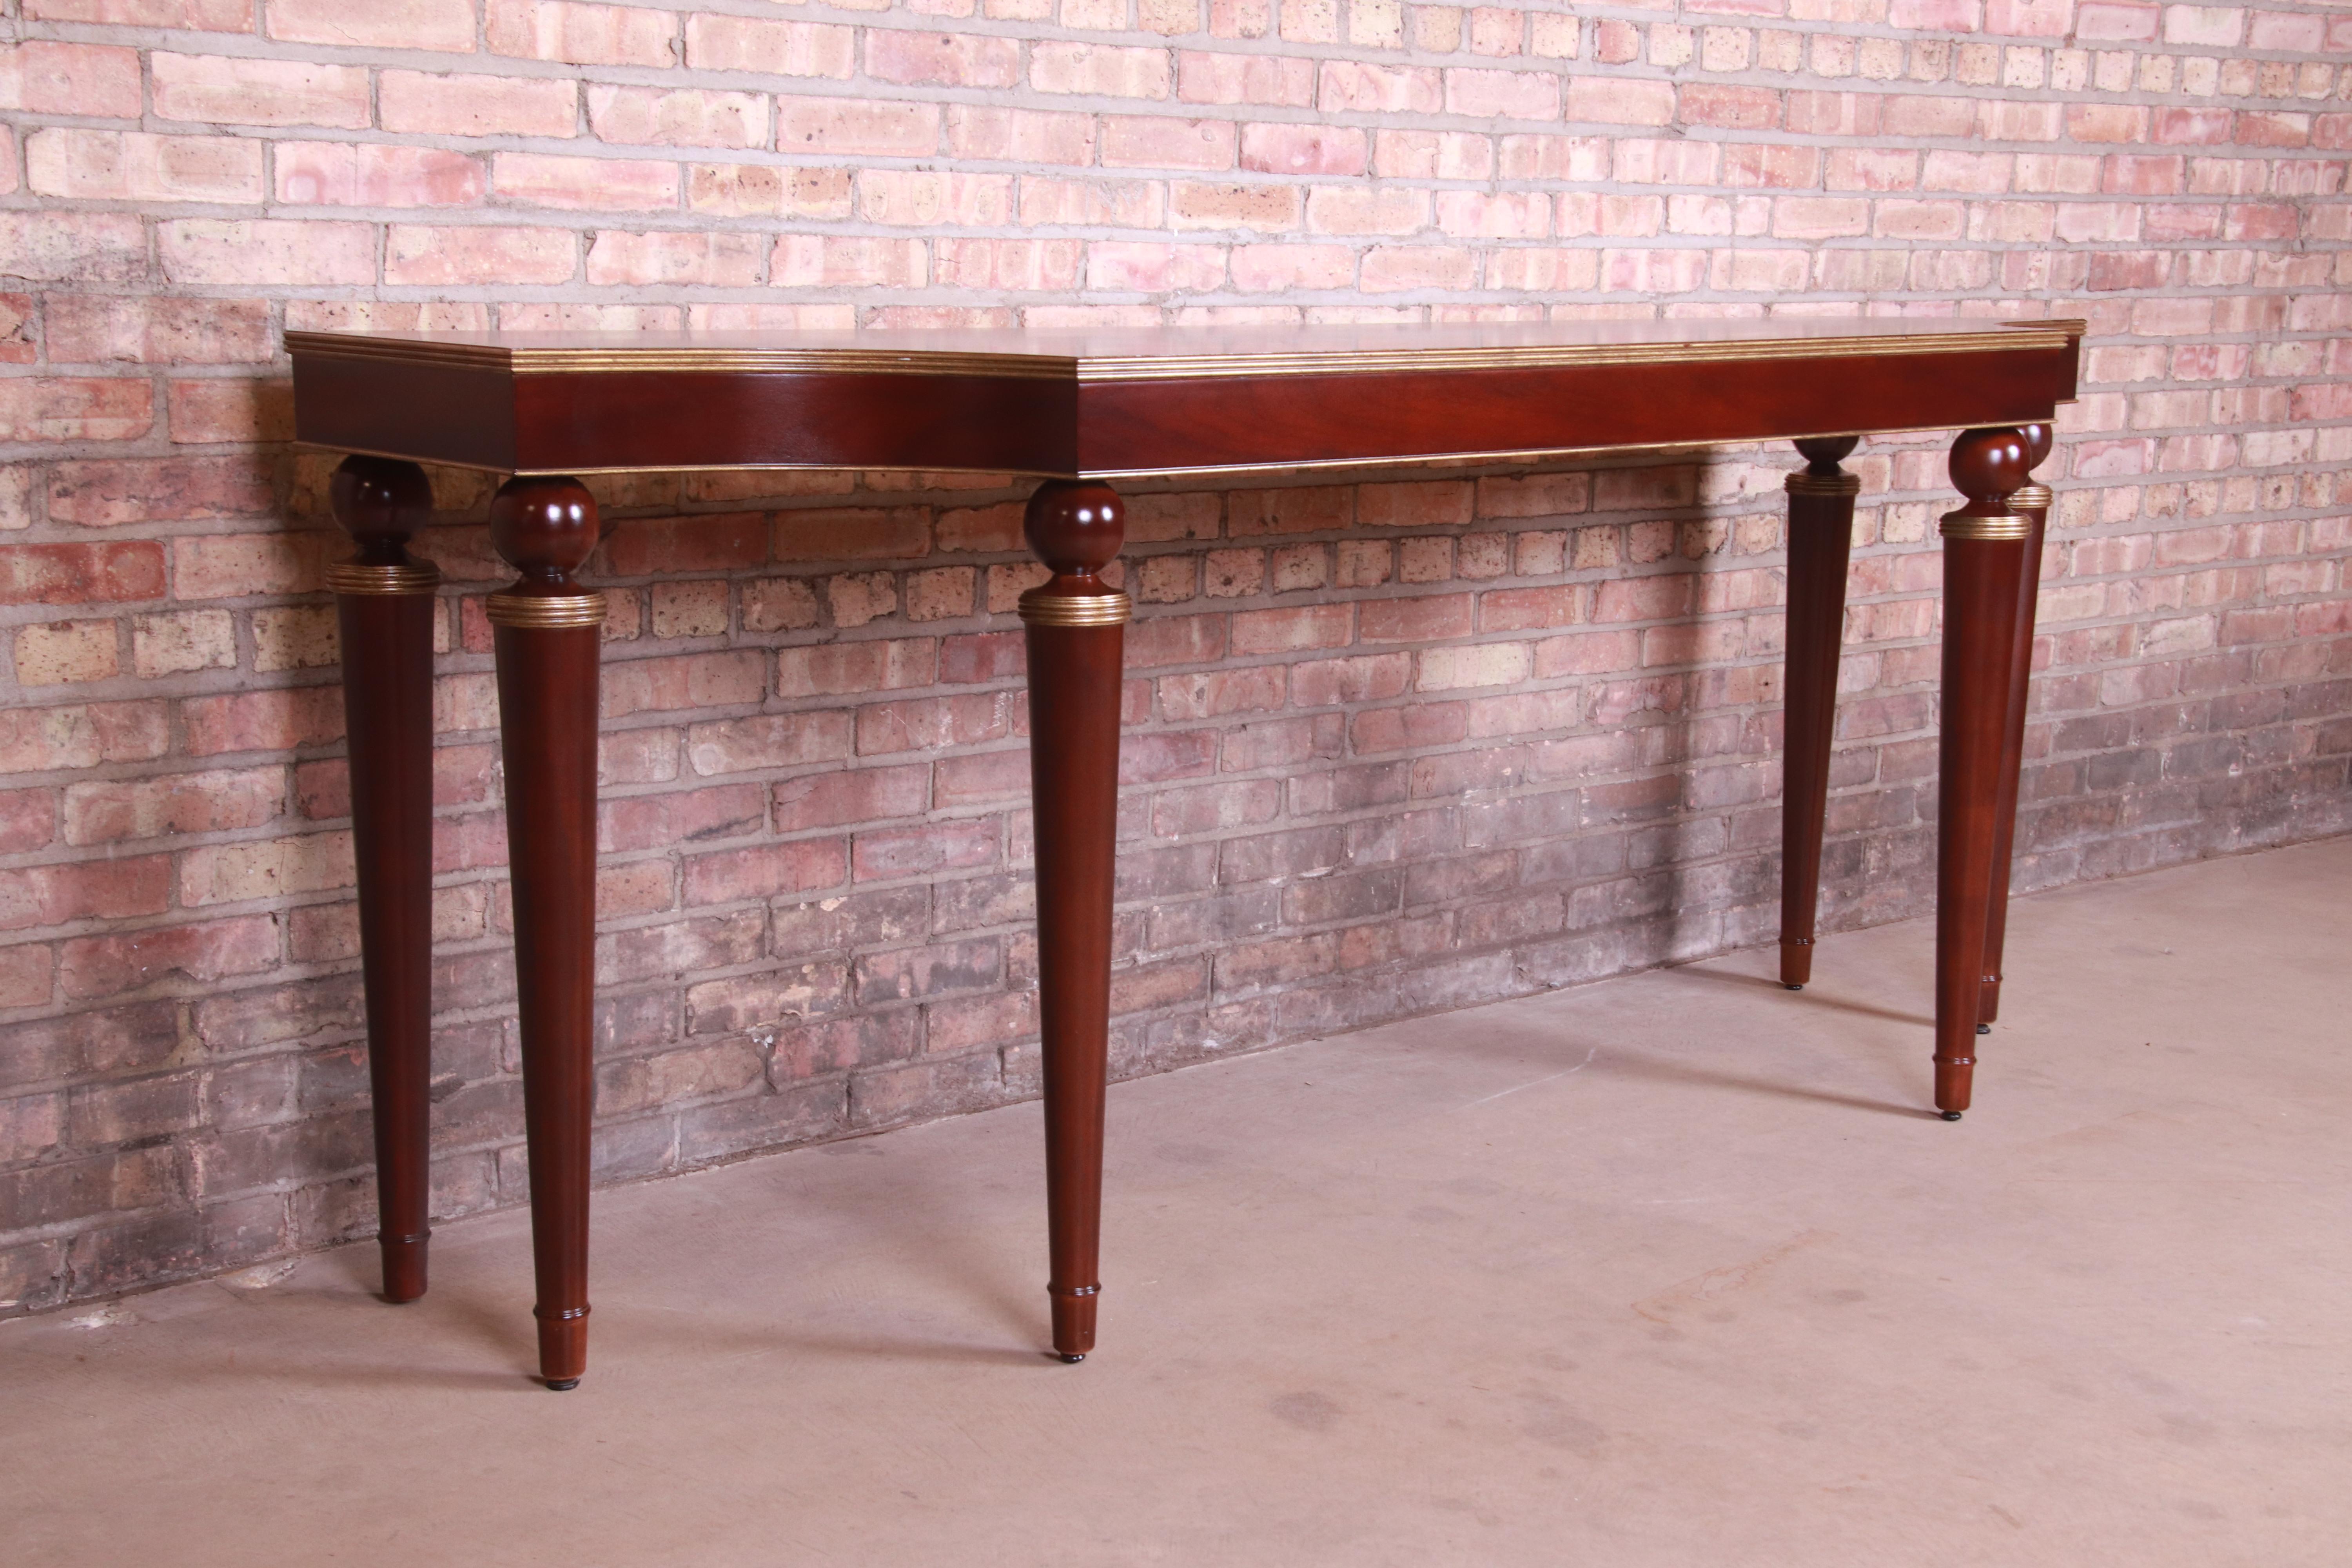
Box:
[0, 0, 2352, 1309]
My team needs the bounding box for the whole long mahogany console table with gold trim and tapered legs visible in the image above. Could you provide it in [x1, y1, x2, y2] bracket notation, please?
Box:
[287, 320, 2084, 1389]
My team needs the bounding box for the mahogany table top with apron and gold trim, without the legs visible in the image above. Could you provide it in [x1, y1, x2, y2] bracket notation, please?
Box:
[287, 318, 2084, 477]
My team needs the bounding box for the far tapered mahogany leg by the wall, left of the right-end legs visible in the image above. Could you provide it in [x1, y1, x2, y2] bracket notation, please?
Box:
[1780, 435, 1863, 990]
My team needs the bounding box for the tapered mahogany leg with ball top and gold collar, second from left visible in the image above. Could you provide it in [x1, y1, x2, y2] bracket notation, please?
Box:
[489, 479, 604, 1389]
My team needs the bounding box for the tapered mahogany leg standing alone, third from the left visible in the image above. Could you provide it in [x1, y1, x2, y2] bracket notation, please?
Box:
[1021, 479, 1134, 1361]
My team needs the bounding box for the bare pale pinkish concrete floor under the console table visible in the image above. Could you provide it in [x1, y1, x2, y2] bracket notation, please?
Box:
[0, 839, 2352, 1568]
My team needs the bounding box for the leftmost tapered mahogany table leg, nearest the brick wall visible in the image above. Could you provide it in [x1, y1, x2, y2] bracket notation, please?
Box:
[327, 458, 440, 1302]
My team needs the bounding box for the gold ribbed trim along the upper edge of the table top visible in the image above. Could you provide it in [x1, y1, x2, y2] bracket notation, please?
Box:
[285, 322, 2084, 383]
